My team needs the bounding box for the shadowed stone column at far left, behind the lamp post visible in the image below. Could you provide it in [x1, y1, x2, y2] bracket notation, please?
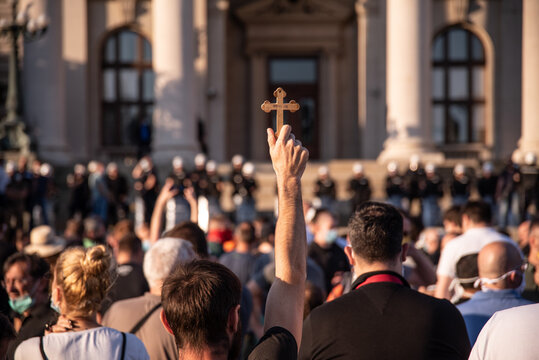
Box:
[23, 0, 71, 165]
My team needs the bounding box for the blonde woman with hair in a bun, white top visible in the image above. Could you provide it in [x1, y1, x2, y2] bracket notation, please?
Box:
[15, 245, 149, 360]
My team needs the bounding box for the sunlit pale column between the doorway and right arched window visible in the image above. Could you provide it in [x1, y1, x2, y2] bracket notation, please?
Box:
[378, 0, 443, 162]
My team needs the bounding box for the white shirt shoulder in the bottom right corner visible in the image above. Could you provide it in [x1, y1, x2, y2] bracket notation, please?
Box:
[469, 304, 539, 360]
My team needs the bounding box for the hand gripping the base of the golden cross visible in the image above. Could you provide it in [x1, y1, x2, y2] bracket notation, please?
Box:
[268, 125, 309, 181]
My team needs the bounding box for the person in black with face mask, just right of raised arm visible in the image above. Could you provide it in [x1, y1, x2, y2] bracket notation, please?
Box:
[307, 209, 350, 293]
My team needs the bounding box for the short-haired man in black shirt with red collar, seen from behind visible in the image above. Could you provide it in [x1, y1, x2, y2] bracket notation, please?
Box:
[299, 202, 470, 359]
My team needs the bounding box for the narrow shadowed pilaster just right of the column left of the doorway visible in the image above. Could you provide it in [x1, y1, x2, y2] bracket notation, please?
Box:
[207, 0, 229, 161]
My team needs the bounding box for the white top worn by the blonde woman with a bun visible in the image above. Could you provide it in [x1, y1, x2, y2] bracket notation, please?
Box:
[15, 327, 150, 360]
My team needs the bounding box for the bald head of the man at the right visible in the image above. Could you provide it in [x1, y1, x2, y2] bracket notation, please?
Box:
[477, 241, 522, 279]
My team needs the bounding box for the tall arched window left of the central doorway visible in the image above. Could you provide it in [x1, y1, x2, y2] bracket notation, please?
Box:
[101, 29, 154, 150]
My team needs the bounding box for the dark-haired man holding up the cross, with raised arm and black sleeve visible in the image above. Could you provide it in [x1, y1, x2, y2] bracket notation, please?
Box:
[161, 125, 309, 360]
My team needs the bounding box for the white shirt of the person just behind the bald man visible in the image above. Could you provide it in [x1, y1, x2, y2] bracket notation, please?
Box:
[436, 227, 517, 278]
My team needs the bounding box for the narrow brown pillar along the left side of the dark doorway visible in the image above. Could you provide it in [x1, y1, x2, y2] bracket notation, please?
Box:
[251, 53, 268, 161]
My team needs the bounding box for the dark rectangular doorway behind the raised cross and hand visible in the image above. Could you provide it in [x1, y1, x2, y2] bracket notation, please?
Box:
[268, 57, 320, 159]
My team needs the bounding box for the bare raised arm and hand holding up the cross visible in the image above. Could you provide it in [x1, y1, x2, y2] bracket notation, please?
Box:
[264, 125, 309, 347]
